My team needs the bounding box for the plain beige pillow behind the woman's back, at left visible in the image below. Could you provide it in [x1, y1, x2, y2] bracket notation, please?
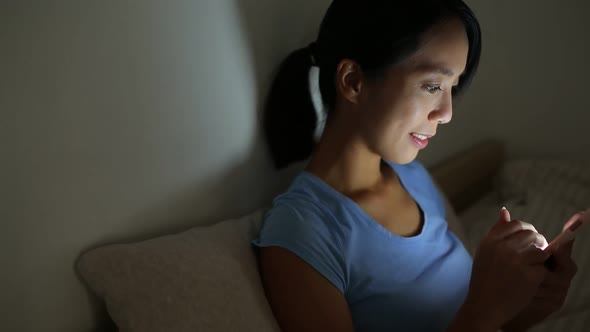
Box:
[77, 210, 279, 332]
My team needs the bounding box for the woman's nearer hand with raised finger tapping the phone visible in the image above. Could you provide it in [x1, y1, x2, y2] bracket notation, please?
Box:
[464, 209, 549, 329]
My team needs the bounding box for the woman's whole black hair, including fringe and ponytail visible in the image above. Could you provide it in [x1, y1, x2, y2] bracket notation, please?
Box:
[263, 0, 481, 169]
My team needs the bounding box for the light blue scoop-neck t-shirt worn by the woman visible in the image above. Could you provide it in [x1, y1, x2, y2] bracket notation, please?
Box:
[253, 161, 472, 332]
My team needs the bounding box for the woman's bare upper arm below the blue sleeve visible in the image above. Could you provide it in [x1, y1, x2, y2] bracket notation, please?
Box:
[260, 247, 354, 332]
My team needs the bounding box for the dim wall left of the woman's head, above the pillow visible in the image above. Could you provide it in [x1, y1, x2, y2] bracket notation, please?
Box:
[0, 0, 328, 331]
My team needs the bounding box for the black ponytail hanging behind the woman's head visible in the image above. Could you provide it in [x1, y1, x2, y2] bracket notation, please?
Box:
[263, 47, 317, 169]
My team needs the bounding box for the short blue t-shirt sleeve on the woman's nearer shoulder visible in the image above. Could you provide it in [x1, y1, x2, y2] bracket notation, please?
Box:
[253, 204, 346, 293]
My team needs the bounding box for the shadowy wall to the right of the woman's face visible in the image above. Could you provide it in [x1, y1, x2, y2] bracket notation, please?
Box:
[421, 0, 590, 164]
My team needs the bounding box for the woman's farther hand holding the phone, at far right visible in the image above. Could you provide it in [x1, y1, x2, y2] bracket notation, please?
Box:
[502, 216, 578, 332]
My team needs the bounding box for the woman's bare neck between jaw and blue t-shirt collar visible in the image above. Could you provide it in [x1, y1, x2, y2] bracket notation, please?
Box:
[306, 112, 395, 196]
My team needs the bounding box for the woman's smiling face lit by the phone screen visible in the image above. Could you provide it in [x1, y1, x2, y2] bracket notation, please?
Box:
[357, 19, 469, 164]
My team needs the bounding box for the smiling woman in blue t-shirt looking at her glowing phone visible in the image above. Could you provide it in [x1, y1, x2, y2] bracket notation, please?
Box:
[254, 0, 575, 332]
